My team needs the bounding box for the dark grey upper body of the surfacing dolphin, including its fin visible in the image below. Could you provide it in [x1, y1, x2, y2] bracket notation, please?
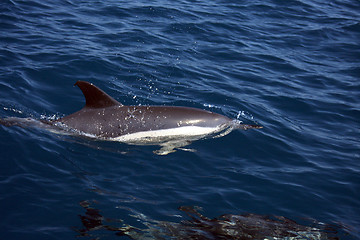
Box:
[55, 81, 260, 139]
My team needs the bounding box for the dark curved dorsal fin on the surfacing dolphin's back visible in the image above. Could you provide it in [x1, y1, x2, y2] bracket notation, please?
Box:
[74, 81, 122, 108]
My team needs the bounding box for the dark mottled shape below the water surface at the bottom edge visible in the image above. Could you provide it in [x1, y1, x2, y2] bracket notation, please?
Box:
[74, 201, 341, 240]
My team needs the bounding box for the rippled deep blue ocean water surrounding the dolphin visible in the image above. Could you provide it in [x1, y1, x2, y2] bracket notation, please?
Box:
[0, 0, 360, 240]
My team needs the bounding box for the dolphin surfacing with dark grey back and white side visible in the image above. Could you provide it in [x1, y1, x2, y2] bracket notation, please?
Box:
[0, 81, 262, 155]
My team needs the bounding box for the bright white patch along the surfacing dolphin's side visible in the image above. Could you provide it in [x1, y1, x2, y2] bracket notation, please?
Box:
[111, 126, 221, 142]
